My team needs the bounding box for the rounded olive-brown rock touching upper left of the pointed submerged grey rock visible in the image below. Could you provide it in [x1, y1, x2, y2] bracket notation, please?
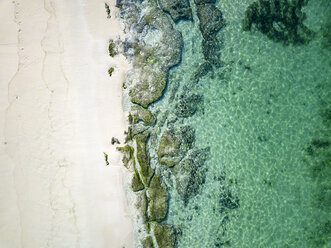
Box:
[157, 126, 195, 167]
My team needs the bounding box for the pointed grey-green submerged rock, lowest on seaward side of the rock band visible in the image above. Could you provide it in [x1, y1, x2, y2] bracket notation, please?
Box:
[172, 148, 209, 205]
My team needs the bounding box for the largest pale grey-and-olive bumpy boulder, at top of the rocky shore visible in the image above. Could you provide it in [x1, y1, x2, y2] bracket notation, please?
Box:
[122, 1, 183, 108]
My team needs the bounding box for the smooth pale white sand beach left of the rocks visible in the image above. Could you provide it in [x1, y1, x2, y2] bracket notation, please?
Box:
[0, 0, 133, 248]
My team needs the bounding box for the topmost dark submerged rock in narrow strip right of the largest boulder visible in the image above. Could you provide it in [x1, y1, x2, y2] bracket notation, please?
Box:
[197, 4, 225, 40]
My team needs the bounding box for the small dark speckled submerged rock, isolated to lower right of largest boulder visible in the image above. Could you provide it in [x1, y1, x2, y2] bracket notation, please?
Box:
[175, 93, 203, 118]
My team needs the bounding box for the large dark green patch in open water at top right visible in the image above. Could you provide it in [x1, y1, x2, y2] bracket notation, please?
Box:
[243, 0, 314, 44]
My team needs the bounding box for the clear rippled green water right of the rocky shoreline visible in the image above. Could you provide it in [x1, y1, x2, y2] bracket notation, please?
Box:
[151, 0, 331, 248]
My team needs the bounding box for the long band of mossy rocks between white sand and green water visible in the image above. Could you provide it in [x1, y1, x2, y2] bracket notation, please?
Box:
[110, 0, 228, 247]
